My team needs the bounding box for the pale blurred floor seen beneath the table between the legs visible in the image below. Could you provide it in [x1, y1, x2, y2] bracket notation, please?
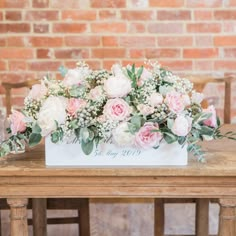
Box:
[1, 199, 219, 236]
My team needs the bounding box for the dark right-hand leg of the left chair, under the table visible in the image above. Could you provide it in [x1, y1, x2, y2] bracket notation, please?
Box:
[79, 199, 90, 236]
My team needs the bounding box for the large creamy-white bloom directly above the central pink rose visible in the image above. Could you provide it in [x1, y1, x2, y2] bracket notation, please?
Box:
[104, 76, 132, 98]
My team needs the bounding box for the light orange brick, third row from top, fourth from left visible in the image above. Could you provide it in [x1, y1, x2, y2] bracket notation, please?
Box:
[91, 22, 126, 33]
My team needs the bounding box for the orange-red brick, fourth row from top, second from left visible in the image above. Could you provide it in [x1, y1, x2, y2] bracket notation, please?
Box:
[30, 36, 63, 47]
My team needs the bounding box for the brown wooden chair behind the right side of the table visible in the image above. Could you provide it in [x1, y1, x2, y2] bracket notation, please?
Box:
[154, 76, 234, 236]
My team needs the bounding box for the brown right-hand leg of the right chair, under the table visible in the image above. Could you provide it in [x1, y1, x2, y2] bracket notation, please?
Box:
[196, 199, 209, 236]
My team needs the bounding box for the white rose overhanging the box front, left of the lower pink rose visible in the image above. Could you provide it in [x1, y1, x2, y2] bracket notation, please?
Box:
[112, 122, 135, 147]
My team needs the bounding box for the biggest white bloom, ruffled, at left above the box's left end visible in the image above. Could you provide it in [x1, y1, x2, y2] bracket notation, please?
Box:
[38, 96, 67, 136]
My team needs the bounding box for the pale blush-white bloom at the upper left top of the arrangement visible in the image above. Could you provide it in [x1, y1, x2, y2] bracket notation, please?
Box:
[62, 67, 91, 87]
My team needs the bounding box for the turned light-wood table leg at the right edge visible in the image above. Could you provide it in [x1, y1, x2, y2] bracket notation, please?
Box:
[219, 198, 236, 236]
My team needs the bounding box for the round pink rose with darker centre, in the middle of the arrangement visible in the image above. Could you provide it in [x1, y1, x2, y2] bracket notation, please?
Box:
[103, 98, 131, 121]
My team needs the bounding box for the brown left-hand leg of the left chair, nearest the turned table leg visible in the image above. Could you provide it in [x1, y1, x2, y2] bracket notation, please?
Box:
[32, 198, 47, 236]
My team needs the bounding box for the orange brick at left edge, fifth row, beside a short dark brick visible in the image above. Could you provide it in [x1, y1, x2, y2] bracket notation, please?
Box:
[0, 48, 34, 59]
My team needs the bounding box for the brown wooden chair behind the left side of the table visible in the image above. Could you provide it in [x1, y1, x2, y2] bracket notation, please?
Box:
[0, 80, 90, 236]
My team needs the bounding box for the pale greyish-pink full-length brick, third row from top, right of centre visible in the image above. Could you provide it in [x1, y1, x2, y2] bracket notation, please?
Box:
[147, 23, 184, 34]
